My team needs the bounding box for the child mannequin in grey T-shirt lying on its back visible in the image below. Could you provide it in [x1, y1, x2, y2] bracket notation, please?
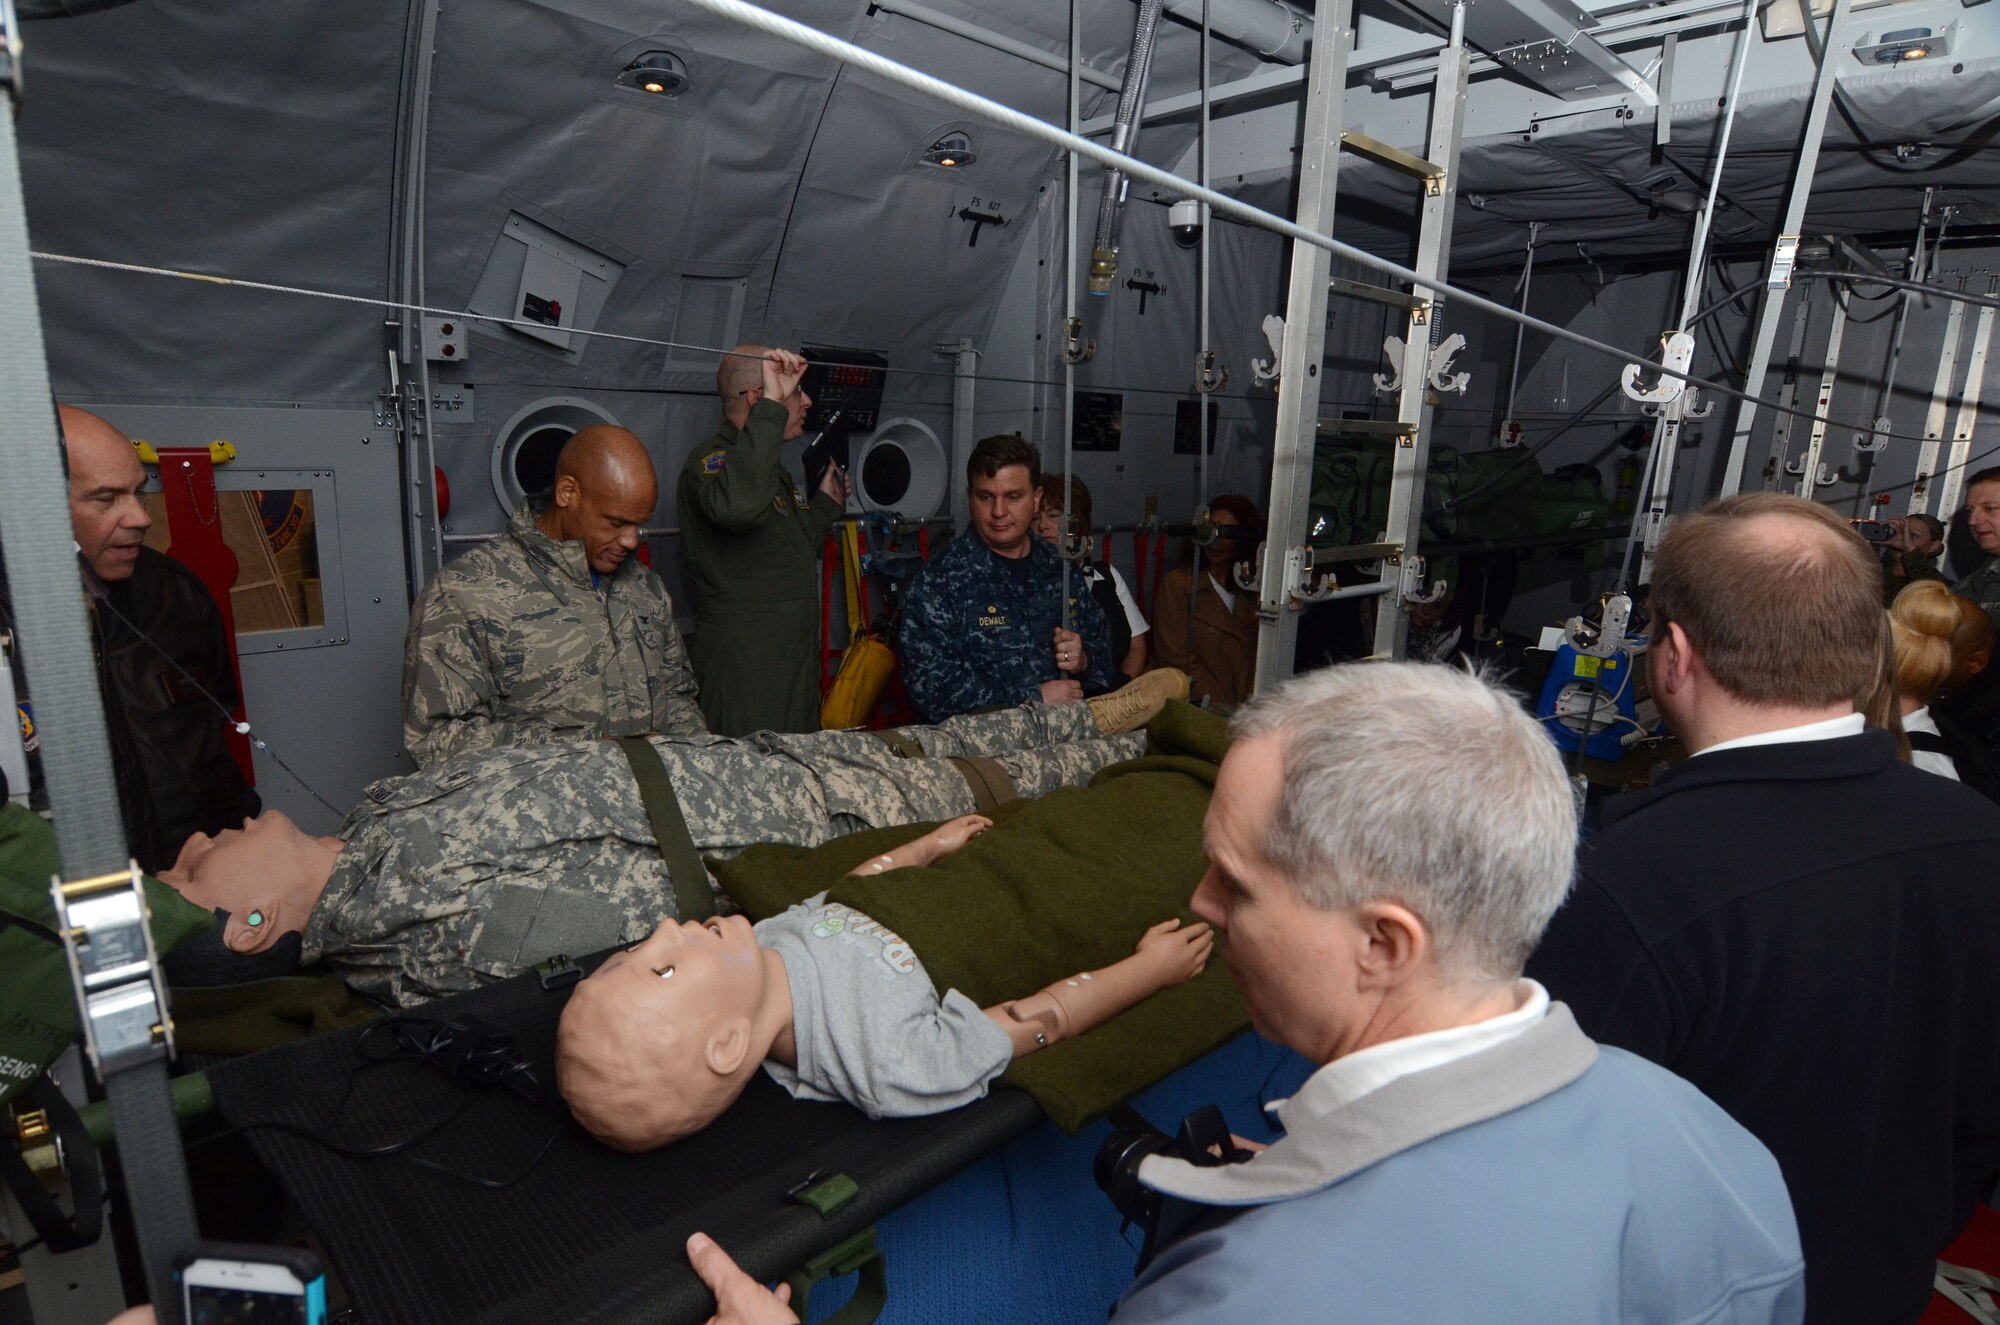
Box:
[556, 815, 1214, 1153]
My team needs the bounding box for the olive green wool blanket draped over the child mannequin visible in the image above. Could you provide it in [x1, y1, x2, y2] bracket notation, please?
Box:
[708, 705, 1248, 1133]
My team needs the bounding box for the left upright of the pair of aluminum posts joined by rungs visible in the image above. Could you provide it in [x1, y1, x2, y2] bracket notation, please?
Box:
[1248, 0, 1354, 693]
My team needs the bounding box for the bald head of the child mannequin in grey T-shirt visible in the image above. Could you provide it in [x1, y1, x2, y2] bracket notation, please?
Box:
[556, 915, 792, 1153]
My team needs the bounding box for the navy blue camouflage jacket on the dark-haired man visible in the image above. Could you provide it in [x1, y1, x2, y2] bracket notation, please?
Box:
[900, 530, 1116, 723]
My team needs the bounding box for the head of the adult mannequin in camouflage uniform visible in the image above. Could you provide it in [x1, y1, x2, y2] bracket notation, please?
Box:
[158, 811, 344, 955]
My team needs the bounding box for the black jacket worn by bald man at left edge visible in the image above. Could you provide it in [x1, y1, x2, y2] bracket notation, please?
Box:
[0, 548, 262, 871]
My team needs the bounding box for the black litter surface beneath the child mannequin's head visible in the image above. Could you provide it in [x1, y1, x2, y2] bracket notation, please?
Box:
[208, 959, 1042, 1325]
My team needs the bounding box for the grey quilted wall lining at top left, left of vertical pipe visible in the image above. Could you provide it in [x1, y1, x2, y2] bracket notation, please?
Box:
[20, 4, 404, 400]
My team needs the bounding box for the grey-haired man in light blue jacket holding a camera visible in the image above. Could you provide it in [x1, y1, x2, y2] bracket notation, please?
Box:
[688, 663, 1804, 1325]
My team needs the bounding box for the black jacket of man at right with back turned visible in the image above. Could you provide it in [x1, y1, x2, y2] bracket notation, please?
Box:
[1528, 731, 2000, 1325]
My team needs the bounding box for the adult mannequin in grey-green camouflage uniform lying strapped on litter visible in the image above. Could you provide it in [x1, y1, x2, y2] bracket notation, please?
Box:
[160, 699, 1160, 1005]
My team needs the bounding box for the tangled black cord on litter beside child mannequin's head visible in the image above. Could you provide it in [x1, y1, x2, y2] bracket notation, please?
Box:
[188, 1017, 562, 1191]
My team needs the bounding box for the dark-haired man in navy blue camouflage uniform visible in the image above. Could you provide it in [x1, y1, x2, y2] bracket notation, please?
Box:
[902, 434, 1116, 723]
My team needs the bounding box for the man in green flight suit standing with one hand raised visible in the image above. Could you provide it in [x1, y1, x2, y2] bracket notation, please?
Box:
[674, 344, 848, 737]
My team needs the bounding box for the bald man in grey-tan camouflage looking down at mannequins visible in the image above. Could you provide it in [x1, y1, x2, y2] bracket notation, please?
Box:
[402, 426, 706, 767]
